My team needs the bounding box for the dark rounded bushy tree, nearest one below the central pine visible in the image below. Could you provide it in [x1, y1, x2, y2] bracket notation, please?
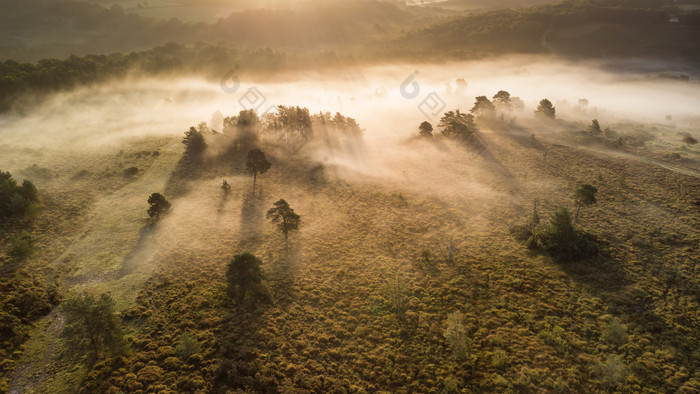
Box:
[226, 252, 267, 302]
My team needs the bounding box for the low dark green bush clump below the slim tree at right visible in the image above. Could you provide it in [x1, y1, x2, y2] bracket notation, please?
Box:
[527, 208, 598, 262]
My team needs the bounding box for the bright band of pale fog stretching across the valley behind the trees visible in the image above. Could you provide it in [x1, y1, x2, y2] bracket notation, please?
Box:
[0, 57, 700, 160]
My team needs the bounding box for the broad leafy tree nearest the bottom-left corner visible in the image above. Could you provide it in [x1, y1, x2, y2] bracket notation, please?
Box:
[61, 293, 124, 358]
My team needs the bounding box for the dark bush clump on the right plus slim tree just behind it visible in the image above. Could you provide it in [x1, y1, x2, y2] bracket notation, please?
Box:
[513, 183, 598, 262]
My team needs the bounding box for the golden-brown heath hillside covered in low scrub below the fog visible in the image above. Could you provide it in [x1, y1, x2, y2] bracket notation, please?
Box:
[4, 106, 700, 392]
